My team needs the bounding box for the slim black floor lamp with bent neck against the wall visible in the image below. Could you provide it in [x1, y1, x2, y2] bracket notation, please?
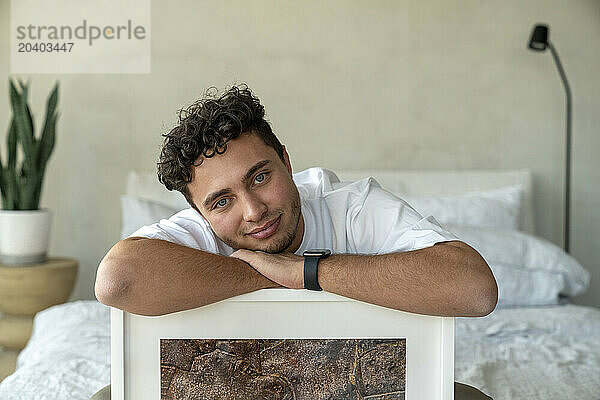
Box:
[529, 24, 571, 253]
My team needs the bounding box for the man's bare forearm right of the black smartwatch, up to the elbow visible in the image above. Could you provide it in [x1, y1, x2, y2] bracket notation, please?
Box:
[318, 245, 497, 316]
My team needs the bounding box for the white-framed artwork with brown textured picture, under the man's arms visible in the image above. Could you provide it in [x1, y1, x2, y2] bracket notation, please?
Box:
[111, 288, 454, 400]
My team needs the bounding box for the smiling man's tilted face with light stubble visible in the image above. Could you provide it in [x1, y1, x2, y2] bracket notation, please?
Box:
[188, 134, 304, 253]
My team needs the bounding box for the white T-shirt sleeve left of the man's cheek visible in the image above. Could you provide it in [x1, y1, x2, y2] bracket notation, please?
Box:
[128, 208, 220, 254]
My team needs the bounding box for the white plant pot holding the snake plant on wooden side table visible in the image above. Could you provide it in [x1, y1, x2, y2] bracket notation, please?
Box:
[0, 208, 52, 265]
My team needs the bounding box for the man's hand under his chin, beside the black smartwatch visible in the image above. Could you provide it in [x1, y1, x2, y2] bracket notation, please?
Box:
[231, 249, 304, 289]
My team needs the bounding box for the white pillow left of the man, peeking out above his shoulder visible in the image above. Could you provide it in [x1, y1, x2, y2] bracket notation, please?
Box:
[121, 195, 181, 239]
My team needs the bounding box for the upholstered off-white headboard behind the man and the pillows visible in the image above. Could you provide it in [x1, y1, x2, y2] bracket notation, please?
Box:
[127, 169, 535, 234]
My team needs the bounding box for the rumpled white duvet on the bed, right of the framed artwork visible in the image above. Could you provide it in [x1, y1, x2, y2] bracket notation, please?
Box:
[454, 305, 600, 400]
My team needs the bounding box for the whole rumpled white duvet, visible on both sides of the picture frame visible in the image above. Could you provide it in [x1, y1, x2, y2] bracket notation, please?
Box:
[0, 301, 600, 400]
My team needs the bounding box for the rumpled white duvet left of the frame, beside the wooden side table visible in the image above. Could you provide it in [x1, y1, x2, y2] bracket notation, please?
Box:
[0, 301, 110, 400]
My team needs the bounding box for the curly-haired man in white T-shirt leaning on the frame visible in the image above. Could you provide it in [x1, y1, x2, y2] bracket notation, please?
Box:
[95, 86, 498, 399]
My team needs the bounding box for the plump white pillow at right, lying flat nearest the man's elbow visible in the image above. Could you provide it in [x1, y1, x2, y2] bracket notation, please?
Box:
[444, 225, 590, 308]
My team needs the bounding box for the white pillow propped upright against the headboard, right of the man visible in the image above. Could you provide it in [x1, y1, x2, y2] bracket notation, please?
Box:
[398, 185, 523, 230]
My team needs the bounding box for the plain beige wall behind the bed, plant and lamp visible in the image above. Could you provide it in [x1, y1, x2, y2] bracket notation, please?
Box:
[0, 0, 600, 306]
